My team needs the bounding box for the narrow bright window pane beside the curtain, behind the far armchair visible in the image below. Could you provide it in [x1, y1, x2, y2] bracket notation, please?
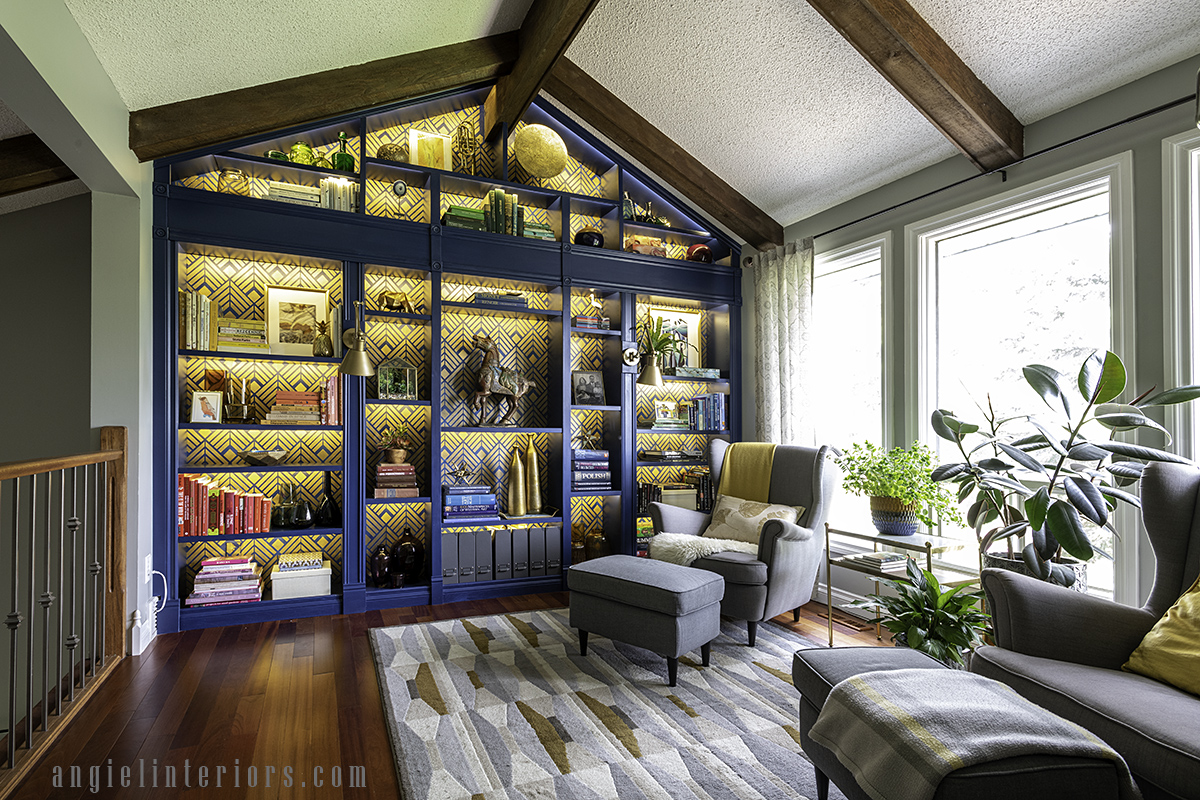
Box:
[811, 240, 887, 530]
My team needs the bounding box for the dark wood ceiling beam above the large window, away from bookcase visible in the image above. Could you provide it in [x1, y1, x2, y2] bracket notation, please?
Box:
[809, 0, 1025, 170]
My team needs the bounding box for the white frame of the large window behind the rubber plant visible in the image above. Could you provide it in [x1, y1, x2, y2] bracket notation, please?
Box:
[904, 151, 1141, 602]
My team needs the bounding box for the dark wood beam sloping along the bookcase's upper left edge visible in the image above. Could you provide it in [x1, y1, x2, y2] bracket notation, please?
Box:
[130, 31, 517, 161]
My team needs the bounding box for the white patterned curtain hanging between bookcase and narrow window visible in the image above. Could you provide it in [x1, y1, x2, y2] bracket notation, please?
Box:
[754, 236, 814, 445]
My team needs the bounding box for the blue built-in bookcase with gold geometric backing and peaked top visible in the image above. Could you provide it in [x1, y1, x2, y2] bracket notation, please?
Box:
[152, 81, 742, 632]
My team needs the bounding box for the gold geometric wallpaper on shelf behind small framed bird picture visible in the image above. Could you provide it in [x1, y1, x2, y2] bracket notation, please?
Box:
[180, 353, 346, 422]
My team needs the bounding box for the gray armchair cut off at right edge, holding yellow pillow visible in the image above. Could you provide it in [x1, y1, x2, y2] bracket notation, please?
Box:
[971, 463, 1200, 800]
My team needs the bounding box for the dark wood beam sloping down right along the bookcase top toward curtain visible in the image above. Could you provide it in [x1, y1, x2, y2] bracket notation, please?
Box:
[545, 58, 784, 249]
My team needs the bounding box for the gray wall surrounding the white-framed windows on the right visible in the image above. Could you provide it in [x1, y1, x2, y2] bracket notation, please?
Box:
[743, 56, 1200, 602]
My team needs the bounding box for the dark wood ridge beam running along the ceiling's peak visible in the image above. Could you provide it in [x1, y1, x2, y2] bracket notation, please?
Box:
[484, 0, 598, 139]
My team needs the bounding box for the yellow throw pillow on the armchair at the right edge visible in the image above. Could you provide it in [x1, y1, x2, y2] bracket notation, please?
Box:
[1121, 578, 1200, 694]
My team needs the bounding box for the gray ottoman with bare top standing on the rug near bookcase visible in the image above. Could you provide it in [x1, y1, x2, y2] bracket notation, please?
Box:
[566, 555, 725, 686]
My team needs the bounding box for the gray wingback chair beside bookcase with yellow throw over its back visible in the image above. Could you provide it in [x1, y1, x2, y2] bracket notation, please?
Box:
[650, 439, 835, 646]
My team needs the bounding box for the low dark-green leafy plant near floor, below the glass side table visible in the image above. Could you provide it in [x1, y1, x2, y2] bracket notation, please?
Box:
[853, 559, 989, 667]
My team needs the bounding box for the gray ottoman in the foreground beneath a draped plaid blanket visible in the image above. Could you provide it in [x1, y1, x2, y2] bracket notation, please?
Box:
[792, 648, 1120, 800]
